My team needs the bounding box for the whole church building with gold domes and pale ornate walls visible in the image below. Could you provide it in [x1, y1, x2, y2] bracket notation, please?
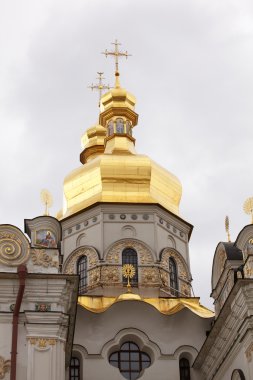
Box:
[0, 45, 253, 380]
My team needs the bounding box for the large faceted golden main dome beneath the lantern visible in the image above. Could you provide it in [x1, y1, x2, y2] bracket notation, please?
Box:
[60, 154, 182, 218]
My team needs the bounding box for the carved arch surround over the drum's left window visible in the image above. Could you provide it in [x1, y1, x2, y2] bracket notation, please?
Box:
[63, 247, 99, 274]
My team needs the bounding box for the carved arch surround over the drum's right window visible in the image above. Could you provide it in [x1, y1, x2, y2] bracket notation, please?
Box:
[160, 248, 191, 281]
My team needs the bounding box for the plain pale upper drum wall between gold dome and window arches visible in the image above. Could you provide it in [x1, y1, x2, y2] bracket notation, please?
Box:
[62, 204, 192, 263]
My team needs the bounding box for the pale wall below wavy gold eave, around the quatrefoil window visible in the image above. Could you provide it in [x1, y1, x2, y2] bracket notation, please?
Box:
[74, 301, 210, 380]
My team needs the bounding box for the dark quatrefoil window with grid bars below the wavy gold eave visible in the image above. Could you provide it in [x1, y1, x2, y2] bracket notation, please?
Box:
[109, 342, 151, 380]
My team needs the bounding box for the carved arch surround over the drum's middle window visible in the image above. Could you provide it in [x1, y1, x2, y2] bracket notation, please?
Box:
[105, 239, 155, 265]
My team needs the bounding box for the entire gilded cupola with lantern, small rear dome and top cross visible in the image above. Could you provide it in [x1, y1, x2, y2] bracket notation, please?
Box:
[58, 42, 182, 219]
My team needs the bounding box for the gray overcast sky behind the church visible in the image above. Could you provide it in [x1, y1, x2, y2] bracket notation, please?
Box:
[0, 0, 253, 306]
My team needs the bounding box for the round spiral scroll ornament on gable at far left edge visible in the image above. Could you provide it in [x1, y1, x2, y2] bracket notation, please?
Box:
[0, 224, 30, 266]
